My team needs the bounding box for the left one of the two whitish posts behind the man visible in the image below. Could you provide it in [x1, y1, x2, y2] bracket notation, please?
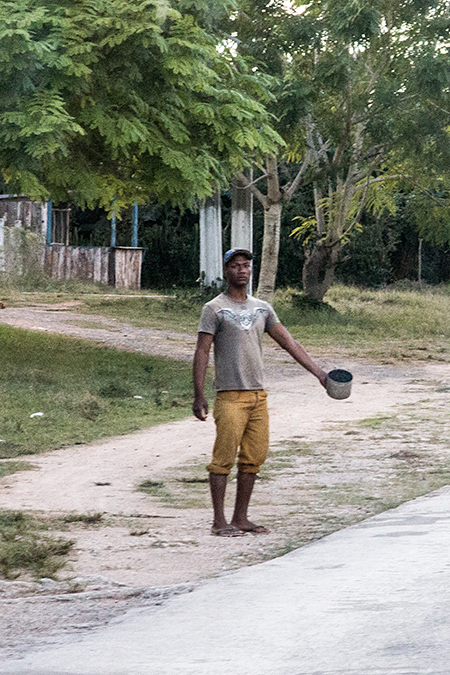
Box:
[200, 190, 223, 286]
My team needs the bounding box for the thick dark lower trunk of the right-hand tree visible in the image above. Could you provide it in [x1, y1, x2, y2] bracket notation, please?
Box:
[302, 241, 341, 302]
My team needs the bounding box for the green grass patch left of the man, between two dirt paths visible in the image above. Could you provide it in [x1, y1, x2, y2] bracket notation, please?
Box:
[0, 324, 213, 458]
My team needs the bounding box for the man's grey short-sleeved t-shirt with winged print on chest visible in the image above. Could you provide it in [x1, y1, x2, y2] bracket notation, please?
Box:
[198, 293, 279, 391]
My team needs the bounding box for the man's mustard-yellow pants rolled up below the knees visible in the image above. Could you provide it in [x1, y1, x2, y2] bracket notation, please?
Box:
[207, 389, 269, 475]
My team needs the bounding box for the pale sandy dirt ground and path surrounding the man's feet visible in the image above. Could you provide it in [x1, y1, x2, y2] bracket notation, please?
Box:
[0, 306, 450, 650]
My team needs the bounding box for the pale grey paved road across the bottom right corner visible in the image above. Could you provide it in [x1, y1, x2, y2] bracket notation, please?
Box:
[0, 487, 450, 675]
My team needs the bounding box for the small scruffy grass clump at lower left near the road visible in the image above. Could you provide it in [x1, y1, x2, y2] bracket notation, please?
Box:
[0, 510, 74, 579]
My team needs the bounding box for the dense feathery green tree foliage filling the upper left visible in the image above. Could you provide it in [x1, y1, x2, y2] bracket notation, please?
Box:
[0, 0, 277, 209]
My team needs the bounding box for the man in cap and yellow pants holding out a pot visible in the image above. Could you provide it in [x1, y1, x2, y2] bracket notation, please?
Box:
[192, 249, 327, 537]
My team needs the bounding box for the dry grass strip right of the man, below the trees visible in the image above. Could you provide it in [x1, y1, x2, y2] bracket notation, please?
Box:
[274, 285, 450, 363]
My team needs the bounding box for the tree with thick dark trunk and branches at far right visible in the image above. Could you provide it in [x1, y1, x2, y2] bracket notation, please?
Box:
[288, 2, 450, 300]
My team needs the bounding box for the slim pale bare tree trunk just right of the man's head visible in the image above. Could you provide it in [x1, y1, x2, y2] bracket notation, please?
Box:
[256, 201, 283, 302]
